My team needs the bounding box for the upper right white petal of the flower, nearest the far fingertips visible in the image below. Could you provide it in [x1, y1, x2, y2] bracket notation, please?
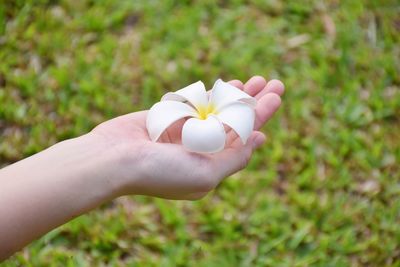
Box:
[210, 79, 257, 109]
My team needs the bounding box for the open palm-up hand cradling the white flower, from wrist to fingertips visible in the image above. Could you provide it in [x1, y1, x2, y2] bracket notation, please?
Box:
[91, 76, 284, 199]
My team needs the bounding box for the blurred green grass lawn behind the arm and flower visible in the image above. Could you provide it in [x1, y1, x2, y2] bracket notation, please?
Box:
[0, 0, 400, 267]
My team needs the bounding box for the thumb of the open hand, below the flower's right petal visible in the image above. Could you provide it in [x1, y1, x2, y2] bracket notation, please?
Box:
[212, 131, 266, 181]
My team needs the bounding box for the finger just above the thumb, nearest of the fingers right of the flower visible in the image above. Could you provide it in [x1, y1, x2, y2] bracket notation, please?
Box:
[254, 93, 281, 130]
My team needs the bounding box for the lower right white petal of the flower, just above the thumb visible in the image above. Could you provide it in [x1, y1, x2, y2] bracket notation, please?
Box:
[217, 102, 255, 144]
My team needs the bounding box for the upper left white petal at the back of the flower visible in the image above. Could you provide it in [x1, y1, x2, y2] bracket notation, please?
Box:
[161, 81, 208, 111]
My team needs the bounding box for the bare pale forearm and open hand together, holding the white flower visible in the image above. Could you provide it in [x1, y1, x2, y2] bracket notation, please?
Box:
[0, 76, 284, 261]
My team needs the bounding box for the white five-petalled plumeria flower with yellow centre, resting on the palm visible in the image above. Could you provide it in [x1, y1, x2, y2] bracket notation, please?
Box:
[146, 80, 256, 153]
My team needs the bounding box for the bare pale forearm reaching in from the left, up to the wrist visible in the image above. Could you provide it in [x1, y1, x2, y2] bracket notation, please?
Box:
[0, 135, 119, 260]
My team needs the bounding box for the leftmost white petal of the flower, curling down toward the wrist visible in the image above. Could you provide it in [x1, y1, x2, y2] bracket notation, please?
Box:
[146, 101, 196, 141]
